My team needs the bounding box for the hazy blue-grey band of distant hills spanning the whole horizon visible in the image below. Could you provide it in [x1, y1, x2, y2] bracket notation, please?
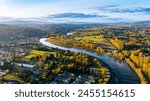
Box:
[0, 21, 150, 40]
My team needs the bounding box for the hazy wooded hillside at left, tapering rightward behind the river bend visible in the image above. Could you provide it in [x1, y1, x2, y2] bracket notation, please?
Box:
[0, 21, 105, 40]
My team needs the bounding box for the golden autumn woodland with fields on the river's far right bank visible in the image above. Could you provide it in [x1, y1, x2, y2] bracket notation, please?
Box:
[49, 28, 150, 83]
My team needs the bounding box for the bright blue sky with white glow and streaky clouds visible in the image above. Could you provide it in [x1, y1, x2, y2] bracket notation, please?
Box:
[0, 0, 150, 23]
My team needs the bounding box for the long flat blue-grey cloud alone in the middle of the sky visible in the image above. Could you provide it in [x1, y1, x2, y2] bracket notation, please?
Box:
[48, 13, 106, 18]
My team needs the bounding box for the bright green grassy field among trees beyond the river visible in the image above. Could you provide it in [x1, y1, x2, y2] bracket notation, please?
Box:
[75, 36, 104, 42]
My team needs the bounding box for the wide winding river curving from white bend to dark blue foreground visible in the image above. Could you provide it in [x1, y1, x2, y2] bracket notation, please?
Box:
[39, 38, 140, 84]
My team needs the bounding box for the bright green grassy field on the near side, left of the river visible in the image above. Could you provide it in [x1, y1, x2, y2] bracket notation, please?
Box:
[23, 50, 56, 60]
